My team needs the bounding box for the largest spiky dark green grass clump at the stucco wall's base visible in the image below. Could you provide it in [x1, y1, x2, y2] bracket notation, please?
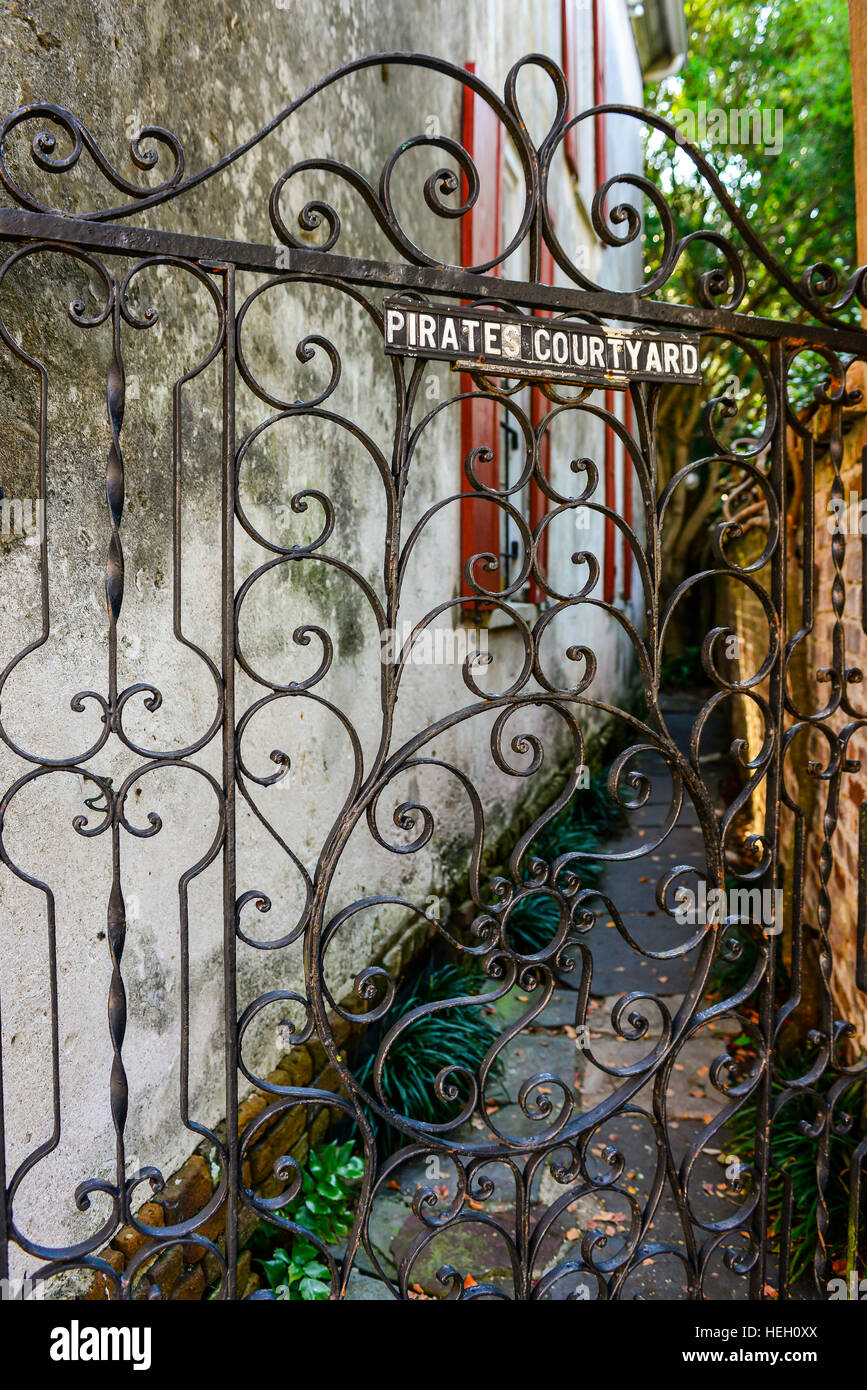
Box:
[358, 963, 502, 1151]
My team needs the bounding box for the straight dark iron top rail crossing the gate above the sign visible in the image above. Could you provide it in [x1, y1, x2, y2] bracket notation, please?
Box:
[0, 207, 867, 357]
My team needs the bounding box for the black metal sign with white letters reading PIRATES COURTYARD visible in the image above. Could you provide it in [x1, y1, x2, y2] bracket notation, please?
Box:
[385, 299, 702, 386]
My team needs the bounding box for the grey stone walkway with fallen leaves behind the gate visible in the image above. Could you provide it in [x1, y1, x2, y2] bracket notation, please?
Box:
[349, 696, 748, 1300]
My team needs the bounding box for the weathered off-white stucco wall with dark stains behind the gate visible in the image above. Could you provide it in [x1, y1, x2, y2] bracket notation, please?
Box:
[0, 0, 642, 1264]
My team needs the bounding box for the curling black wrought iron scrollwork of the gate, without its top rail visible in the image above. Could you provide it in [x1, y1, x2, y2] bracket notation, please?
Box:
[0, 53, 867, 1300]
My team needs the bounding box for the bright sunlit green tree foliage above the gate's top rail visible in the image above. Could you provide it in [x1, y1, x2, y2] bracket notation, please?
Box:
[646, 0, 854, 317]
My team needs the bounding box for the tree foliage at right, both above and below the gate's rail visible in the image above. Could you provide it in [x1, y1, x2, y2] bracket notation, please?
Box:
[645, 0, 857, 641]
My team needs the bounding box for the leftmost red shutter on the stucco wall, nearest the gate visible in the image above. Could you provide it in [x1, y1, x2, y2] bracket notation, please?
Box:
[461, 63, 503, 594]
